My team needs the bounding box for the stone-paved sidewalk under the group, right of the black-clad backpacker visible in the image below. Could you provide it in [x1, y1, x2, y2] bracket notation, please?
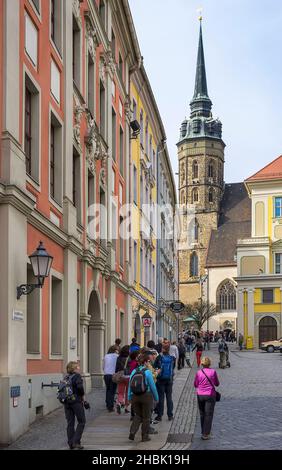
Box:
[75, 367, 193, 450]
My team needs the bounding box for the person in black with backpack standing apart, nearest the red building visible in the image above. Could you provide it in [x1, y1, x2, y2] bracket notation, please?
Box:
[57, 361, 86, 450]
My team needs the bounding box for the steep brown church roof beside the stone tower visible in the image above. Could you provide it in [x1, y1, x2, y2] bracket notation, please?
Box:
[206, 183, 251, 267]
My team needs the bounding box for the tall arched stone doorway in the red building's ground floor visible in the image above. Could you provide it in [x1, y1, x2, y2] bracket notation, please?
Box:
[88, 290, 105, 386]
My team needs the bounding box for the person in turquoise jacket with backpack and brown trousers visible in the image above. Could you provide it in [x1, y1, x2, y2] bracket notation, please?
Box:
[128, 353, 159, 442]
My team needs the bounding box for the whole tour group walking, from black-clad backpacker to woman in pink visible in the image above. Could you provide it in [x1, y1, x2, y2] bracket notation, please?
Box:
[58, 332, 242, 449]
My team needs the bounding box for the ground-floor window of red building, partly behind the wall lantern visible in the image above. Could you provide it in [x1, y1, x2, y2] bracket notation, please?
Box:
[26, 266, 41, 354]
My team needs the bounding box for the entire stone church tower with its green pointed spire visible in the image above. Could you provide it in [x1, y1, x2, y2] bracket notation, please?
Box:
[177, 18, 225, 303]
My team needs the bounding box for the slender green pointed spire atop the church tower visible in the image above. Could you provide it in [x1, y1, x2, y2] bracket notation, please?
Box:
[190, 17, 212, 117]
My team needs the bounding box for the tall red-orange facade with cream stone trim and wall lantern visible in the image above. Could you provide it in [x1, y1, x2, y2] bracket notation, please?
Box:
[0, 0, 141, 443]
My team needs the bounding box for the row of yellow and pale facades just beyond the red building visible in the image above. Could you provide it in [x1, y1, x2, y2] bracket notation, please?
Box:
[131, 65, 176, 345]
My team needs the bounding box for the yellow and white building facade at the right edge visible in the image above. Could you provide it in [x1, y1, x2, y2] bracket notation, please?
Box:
[236, 156, 282, 348]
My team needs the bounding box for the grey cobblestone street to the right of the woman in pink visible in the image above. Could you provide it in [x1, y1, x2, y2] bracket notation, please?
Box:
[191, 347, 282, 450]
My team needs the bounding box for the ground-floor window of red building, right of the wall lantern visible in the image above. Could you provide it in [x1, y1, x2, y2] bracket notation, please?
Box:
[51, 277, 63, 356]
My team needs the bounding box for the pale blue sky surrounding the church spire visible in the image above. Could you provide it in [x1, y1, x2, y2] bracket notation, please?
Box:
[129, 0, 282, 186]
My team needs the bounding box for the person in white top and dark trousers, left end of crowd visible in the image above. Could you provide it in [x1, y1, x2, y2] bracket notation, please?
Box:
[103, 344, 118, 412]
